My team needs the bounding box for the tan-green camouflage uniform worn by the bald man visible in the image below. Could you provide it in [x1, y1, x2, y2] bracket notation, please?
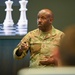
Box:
[14, 26, 64, 67]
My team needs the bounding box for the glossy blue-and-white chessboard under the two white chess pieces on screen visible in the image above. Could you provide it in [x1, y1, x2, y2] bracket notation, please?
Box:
[0, 24, 27, 36]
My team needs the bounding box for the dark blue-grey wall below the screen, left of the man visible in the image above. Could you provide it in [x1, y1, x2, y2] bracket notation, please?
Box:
[0, 37, 29, 75]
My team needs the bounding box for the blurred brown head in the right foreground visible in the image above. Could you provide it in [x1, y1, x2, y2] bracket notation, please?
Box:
[59, 25, 75, 66]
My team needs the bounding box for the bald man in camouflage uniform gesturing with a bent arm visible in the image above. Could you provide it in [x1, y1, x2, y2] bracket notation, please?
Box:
[13, 9, 64, 67]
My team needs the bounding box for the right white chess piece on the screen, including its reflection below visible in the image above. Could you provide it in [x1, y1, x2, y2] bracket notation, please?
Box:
[17, 0, 28, 35]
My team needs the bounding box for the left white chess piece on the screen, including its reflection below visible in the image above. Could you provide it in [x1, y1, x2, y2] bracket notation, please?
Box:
[3, 0, 14, 35]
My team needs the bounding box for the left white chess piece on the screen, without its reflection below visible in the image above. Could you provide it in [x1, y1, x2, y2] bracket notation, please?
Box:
[3, 0, 14, 28]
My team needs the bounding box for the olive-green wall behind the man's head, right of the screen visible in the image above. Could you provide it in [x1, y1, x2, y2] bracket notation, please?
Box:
[27, 0, 75, 30]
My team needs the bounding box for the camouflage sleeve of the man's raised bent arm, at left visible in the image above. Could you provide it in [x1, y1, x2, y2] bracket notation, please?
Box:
[13, 33, 30, 59]
